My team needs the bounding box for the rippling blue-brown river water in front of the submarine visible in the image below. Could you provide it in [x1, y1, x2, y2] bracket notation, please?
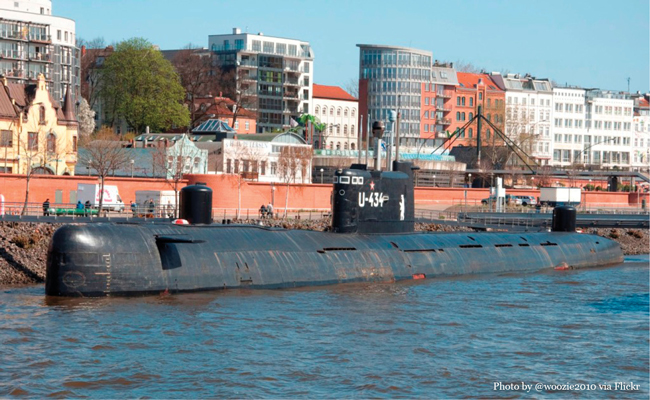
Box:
[0, 255, 650, 399]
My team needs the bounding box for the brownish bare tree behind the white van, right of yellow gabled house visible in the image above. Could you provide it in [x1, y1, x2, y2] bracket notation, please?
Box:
[81, 128, 129, 212]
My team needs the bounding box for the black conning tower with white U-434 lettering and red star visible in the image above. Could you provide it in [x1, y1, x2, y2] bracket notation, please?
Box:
[332, 161, 417, 233]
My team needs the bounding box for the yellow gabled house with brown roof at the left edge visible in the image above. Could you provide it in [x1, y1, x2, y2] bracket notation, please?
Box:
[0, 74, 78, 175]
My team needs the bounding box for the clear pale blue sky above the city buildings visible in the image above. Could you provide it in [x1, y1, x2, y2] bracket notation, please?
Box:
[57, 0, 650, 92]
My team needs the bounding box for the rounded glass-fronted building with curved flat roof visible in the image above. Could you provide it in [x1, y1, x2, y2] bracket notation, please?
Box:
[357, 44, 433, 137]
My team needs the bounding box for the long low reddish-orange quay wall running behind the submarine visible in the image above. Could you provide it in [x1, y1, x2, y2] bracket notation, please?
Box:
[0, 174, 649, 210]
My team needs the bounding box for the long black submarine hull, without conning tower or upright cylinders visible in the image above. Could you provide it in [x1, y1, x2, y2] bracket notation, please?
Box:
[45, 223, 623, 296]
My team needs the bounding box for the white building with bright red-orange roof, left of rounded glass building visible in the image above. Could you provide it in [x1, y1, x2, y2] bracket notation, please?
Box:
[313, 84, 359, 150]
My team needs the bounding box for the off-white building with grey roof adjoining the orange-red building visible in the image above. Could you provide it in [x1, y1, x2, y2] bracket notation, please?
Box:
[490, 72, 552, 165]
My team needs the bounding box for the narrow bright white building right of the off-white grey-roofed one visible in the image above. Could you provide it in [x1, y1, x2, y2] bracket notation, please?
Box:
[551, 87, 591, 166]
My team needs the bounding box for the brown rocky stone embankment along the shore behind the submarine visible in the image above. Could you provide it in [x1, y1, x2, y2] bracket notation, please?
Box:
[0, 219, 650, 285]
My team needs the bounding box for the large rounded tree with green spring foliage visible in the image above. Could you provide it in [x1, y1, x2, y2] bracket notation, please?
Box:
[100, 38, 189, 133]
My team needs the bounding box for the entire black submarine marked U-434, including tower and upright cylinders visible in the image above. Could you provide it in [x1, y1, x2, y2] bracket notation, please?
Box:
[45, 161, 623, 297]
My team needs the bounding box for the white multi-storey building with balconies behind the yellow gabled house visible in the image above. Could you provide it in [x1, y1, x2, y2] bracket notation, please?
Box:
[0, 0, 80, 103]
